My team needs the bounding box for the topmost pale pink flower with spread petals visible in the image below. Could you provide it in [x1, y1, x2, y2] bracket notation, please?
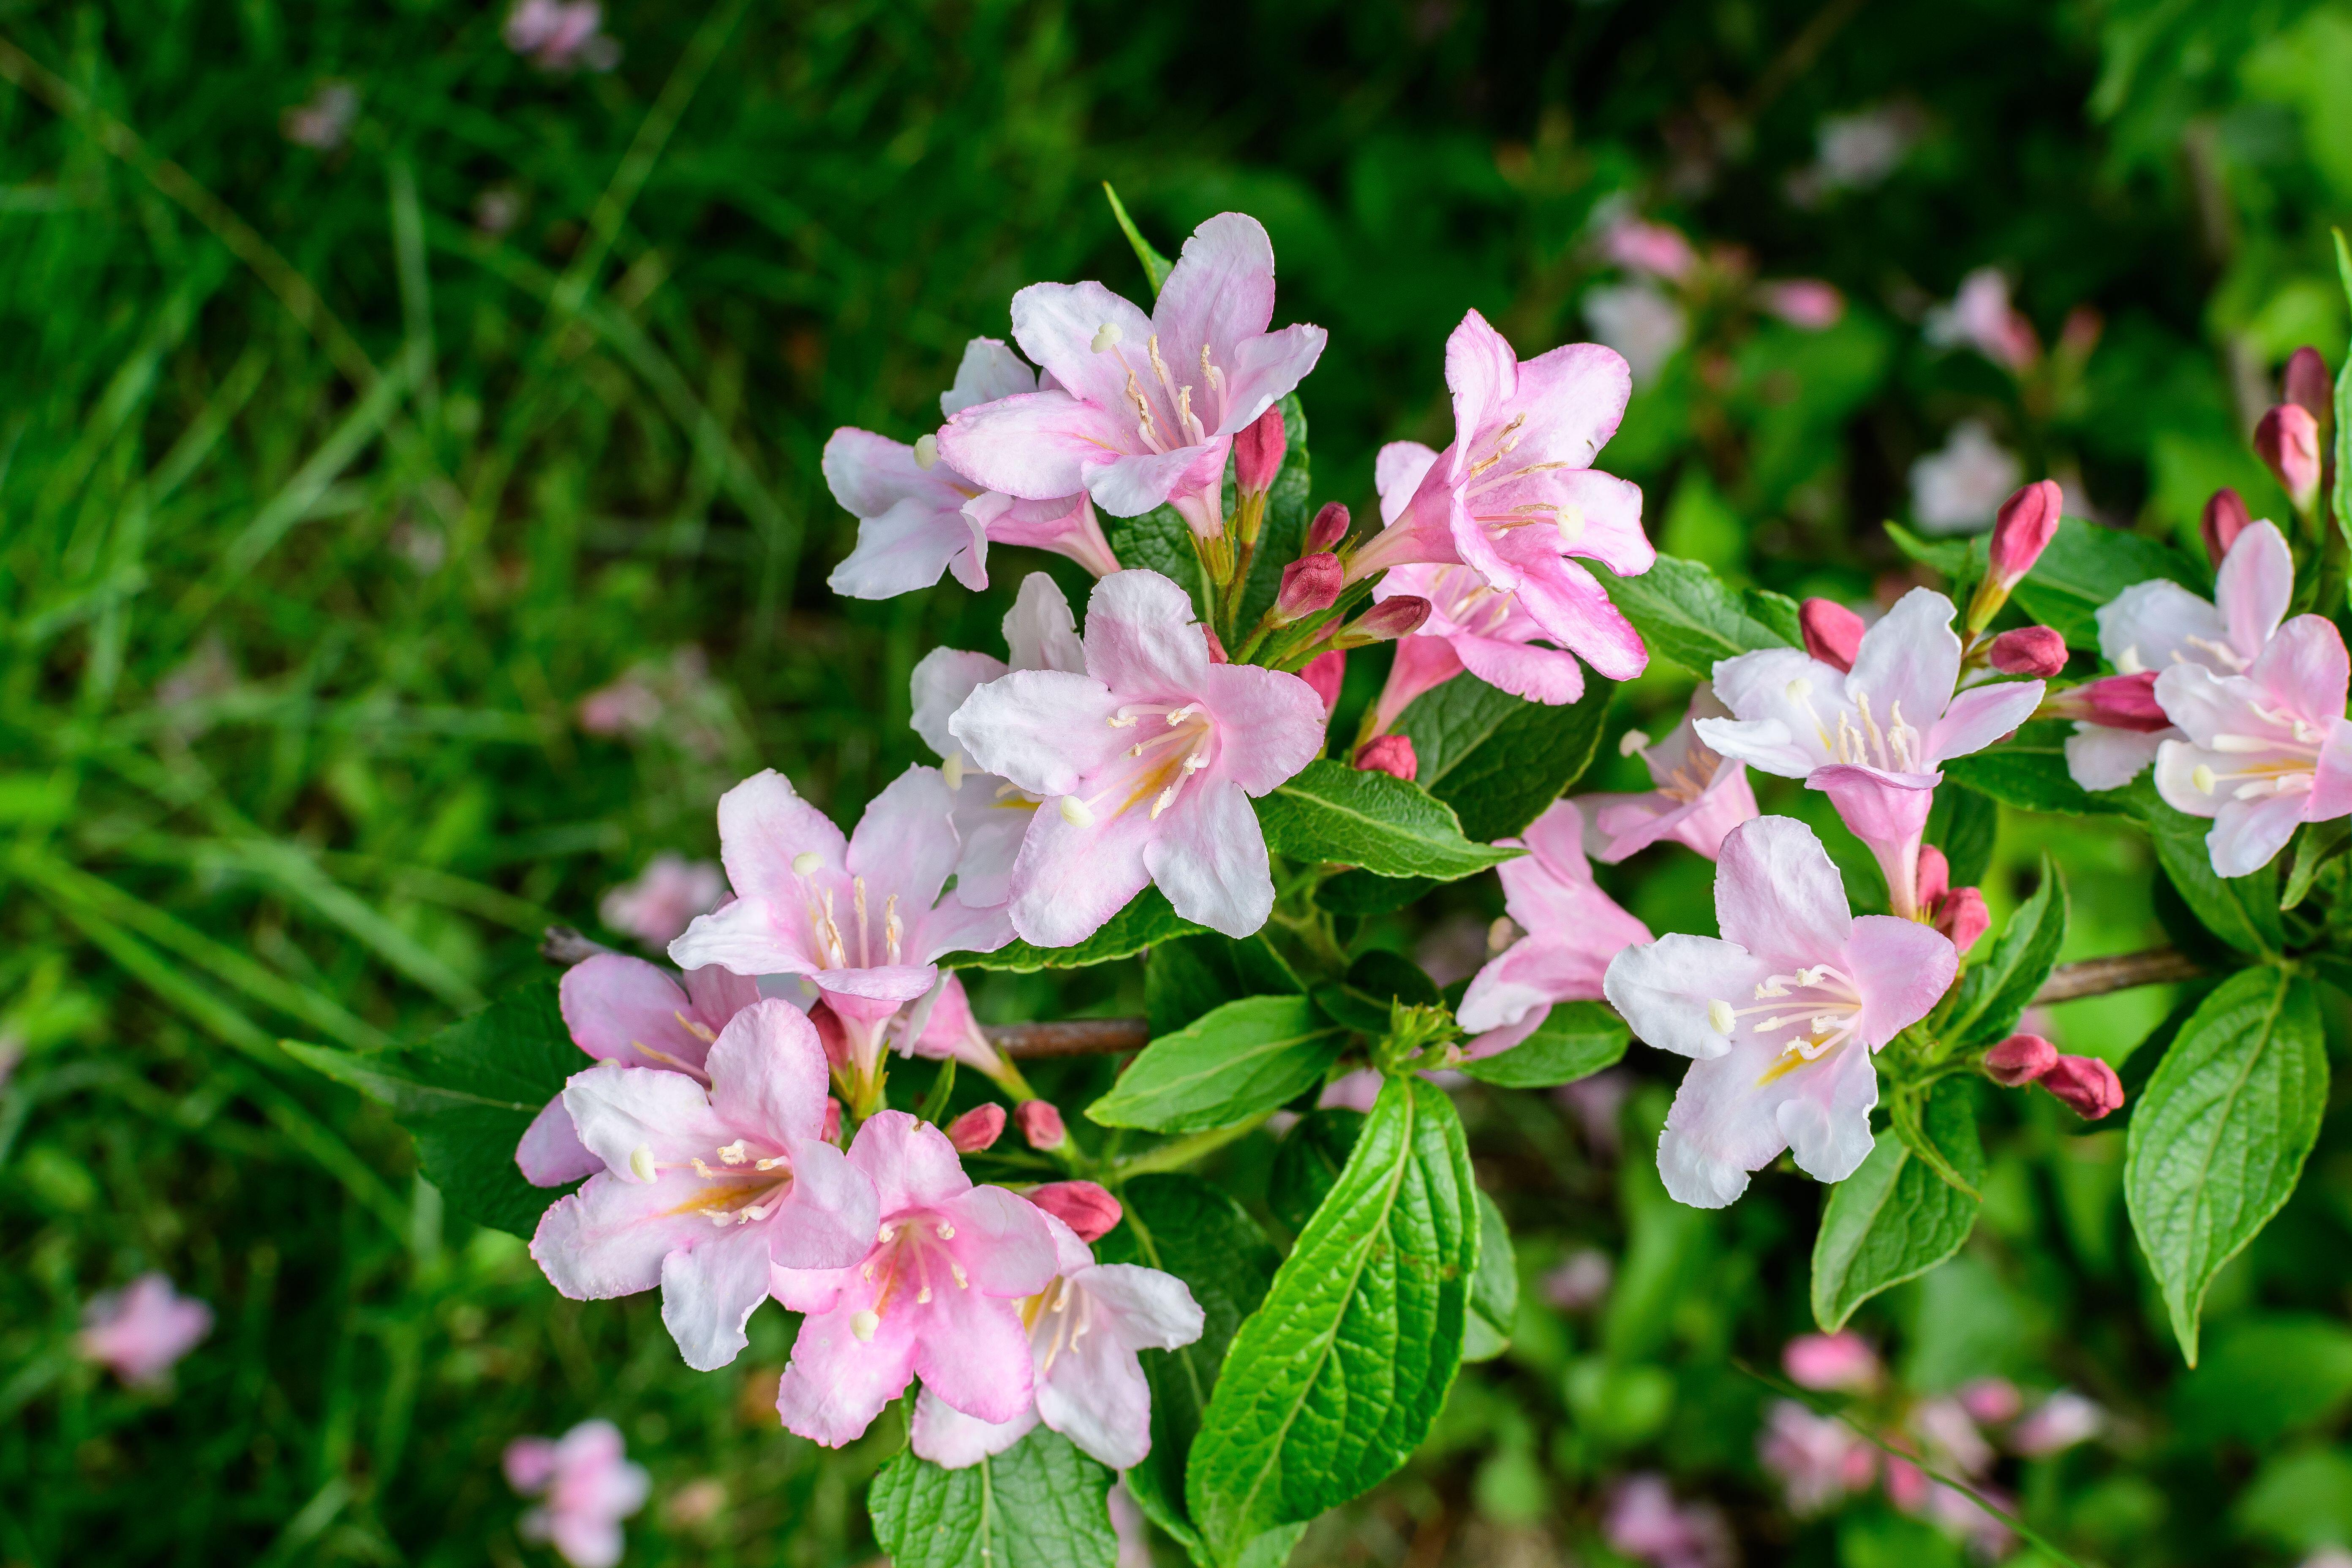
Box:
[939, 212, 1324, 538]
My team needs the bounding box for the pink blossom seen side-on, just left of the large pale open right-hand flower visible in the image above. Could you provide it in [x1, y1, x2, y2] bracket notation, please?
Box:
[1456, 799, 1649, 1058]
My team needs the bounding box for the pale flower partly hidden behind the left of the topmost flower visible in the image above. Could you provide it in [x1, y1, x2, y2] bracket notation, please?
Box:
[825, 338, 1119, 599]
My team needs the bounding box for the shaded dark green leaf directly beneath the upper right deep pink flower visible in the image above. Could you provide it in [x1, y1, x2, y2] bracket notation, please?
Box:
[1397, 675, 1616, 844]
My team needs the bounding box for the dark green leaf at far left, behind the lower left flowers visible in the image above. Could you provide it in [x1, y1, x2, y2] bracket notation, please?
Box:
[285, 978, 595, 1236]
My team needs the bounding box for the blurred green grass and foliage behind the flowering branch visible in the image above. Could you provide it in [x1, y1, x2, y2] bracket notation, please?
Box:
[0, 0, 2352, 1568]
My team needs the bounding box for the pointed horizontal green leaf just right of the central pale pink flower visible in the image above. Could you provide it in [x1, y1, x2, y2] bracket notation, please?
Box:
[1258, 757, 1517, 882]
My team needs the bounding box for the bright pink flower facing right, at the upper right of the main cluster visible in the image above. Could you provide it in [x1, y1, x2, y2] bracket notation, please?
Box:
[1348, 310, 1658, 679]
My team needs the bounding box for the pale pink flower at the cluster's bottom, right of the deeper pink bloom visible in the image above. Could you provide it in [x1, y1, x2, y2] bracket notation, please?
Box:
[908, 1213, 1206, 1469]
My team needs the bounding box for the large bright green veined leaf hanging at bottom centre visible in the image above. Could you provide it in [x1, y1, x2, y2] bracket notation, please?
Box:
[1185, 1077, 1479, 1561]
